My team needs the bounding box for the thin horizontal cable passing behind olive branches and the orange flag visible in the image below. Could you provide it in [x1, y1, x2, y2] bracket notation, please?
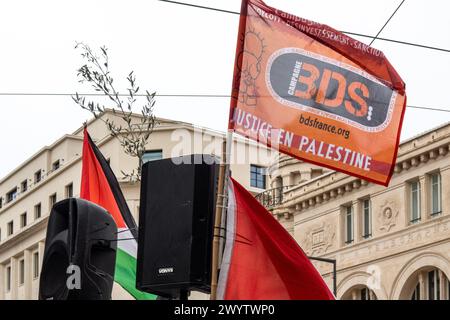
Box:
[0, 92, 450, 113]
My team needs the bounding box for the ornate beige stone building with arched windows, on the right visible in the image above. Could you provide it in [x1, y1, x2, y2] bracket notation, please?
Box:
[264, 125, 450, 300]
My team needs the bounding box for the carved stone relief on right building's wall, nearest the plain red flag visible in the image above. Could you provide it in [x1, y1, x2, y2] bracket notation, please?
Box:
[302, 222, 336, 256]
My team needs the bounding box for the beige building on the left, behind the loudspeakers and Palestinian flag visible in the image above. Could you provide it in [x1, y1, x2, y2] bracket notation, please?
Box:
[0, 111, 273, 300]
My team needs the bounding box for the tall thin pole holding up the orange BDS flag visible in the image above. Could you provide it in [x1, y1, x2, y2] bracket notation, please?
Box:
[210, 0, 248, 300]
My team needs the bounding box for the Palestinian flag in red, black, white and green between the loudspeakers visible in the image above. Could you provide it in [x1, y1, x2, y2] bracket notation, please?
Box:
[80, 128, 157, 300]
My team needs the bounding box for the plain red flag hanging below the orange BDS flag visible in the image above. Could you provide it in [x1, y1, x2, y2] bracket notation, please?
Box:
[218, 179, 334, 300]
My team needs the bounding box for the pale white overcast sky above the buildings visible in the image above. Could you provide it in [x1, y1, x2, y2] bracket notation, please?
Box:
[0, 0, 450, 177]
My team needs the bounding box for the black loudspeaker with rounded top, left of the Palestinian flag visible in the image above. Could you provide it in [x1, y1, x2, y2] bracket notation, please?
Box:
[39, 198, 117, 300]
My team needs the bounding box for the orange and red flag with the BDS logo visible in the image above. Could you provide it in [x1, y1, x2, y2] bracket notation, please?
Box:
[229, 0, 406, 185]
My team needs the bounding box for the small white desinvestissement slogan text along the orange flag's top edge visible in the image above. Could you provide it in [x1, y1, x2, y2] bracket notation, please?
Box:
[254, 7, 384, 57]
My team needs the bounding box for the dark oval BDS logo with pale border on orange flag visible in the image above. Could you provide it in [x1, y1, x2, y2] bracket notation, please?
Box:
[266, 48, 397, 132]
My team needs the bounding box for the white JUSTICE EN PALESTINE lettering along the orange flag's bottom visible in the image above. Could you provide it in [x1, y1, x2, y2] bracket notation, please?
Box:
[233, 108, 372, 171]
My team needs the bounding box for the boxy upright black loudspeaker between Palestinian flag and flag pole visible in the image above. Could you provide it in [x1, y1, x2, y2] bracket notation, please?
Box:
[136, 155, 218, 298]
